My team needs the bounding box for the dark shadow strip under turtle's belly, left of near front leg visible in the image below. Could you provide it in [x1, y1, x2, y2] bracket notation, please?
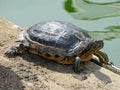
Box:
[21, 53, 75, 74]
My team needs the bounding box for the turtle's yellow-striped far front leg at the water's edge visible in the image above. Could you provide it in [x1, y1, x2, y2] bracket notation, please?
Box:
[94, 51, 113, 65]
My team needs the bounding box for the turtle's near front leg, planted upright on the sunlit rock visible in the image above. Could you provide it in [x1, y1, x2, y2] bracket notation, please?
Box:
[73, 57, 83, 73]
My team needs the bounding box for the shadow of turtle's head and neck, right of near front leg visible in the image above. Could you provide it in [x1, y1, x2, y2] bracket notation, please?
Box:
[74, 60, 112, 84]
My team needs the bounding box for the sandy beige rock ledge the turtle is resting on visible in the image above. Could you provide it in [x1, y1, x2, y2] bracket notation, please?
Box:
[0, 19, 120, 90]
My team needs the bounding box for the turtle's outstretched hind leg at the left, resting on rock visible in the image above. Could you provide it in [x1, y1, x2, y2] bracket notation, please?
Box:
[4, 44, 27, 57]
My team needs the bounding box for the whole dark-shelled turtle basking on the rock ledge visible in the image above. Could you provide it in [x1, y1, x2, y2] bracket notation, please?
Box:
[5, 20, 109, 72]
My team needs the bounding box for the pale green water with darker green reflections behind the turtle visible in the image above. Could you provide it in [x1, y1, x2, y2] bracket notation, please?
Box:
[0, 0, 120, 68]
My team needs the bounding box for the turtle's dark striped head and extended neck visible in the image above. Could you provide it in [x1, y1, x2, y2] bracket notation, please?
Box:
[81, 40, 104, 57]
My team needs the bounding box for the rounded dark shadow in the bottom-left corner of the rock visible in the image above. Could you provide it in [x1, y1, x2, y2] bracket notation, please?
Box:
[0, 65, 23, 90]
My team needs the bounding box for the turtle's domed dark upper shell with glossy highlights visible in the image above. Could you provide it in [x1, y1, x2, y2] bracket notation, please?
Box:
[27, 21, 92, 56]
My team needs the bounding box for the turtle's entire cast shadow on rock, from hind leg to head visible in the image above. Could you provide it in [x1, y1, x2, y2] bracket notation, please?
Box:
[21, 53, 112, 84]
